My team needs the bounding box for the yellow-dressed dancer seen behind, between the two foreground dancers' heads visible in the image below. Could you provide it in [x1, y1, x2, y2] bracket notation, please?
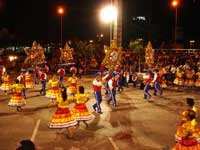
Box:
[68, 67, 78, 94]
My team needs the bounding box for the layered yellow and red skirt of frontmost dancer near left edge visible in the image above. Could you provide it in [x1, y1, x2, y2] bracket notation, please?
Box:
[8, 93, 26, 107]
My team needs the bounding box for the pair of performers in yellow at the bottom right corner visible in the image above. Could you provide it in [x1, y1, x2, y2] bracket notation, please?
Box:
[172, 98, 200, 150]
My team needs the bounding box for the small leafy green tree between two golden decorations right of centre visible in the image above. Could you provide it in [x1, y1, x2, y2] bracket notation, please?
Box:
[129, 39, 144, 72]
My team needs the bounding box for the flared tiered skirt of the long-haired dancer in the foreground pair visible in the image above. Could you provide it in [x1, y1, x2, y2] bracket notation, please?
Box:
[48, 108, 78, 129]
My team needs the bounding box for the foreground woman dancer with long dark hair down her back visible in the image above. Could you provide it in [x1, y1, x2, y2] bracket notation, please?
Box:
[48, 87, 78, 137]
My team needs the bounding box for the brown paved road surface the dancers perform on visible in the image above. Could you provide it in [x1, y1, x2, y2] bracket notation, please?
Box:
[0, 78, 200, 150]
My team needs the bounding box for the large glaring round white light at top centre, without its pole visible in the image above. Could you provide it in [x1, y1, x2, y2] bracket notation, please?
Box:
[100, 6, 117, 23]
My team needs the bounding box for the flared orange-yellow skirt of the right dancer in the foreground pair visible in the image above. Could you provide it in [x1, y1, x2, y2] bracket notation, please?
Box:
[72, 104, 94, 121]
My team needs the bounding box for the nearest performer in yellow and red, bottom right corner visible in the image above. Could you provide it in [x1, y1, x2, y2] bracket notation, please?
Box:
[172, 110, 200, 150]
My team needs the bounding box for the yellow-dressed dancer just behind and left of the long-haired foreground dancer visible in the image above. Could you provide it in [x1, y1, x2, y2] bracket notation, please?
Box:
[45, 75, 61, 102]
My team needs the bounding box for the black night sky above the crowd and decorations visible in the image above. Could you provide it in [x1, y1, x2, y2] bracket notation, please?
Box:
[0, 0, 200, 45]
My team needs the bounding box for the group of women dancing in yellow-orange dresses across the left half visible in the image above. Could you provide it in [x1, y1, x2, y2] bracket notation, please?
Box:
[0, 67, 94, 137]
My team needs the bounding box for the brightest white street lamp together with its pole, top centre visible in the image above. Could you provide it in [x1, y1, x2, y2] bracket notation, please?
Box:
[100, 5, 117, 45]
